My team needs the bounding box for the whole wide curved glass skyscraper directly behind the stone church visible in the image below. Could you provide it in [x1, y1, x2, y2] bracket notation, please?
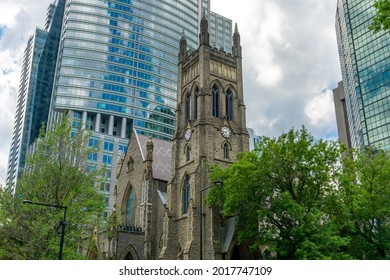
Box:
[6, 0, 232, 215]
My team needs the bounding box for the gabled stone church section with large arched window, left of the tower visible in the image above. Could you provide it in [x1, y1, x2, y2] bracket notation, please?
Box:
[115, 130, 172, 259]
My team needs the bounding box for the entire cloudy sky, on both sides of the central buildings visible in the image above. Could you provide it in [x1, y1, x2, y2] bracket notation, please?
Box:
[0, 0, 341, 182]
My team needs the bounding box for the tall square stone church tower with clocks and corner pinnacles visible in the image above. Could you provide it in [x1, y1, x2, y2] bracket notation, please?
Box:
[159, 14, 249, 259]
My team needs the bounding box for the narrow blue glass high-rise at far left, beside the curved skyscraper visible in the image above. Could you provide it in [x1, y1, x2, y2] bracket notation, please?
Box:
[6, 0, 65, 188]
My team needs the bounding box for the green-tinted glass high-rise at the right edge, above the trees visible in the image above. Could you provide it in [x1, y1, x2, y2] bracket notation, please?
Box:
[336, 0, 390, 149]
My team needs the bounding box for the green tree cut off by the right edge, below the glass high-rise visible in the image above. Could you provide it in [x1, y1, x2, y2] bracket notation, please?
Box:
[339, 149, 390, 259]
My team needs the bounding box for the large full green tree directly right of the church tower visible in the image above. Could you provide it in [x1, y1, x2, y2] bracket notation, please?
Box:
[207, 128, 349, 259]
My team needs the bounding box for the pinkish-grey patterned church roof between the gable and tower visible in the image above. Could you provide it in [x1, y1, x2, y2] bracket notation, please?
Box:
[134, 130, 172, 181]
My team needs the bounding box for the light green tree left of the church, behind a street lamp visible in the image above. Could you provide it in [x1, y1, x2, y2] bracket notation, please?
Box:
[0, 116, 104, 259]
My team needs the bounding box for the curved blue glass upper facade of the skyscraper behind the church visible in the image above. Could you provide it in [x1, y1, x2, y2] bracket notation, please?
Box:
[52, 0, 198, 139]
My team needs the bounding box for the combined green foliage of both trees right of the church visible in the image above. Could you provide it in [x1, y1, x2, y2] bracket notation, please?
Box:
[207, 128, 390, 259]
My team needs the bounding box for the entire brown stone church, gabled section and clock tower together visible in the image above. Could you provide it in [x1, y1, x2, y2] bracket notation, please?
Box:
[111, 17, 250, 259]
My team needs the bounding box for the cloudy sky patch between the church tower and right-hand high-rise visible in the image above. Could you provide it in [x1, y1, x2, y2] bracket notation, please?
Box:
[211, 0, 341, 138]
